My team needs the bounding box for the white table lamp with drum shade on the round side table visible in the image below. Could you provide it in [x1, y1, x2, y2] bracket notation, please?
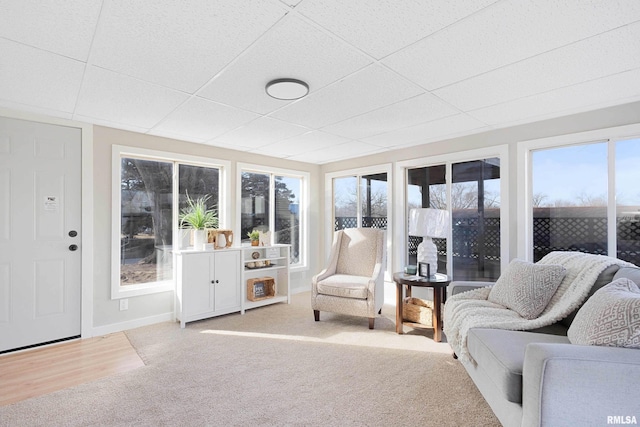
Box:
[409, 208, 449, 276]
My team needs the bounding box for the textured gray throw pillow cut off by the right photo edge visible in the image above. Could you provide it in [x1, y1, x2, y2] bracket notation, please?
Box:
[567, 279, 640, 348]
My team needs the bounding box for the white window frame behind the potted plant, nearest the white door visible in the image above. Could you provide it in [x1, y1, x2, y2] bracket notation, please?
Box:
[111, 144, 231, 300]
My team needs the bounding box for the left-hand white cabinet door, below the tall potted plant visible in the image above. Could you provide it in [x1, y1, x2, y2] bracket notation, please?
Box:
[182, 253, 214, 316]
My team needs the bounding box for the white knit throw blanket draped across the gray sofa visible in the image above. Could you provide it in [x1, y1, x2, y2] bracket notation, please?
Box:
[443, 252, 633, 363]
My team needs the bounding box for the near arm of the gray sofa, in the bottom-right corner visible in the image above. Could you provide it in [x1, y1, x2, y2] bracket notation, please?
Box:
[522, 343, 640, 426]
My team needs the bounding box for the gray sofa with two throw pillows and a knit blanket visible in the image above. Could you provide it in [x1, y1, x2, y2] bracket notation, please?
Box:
[449, 266, 640, 427]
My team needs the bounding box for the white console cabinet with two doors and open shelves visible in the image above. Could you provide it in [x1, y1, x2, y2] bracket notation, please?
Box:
[176, 245, 290, 328]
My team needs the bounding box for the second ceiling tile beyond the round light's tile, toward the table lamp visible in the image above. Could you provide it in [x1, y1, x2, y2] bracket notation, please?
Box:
[323, 93, 460, 139]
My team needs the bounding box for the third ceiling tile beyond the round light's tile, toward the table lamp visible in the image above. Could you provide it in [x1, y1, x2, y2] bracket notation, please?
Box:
[363, 114, 488, 148]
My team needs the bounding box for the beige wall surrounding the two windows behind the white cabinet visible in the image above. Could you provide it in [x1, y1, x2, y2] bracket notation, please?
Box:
[93, 126, 321, 335]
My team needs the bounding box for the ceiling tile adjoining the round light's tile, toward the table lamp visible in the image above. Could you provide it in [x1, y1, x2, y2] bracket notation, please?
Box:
[272, 65, 424, 129]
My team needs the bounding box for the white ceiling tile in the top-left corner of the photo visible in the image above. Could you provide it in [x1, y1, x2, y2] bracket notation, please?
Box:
[0, 0, 102, 61]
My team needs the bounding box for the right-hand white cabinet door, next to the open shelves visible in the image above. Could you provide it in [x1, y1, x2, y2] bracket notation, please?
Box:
[214, 251, 240, 311]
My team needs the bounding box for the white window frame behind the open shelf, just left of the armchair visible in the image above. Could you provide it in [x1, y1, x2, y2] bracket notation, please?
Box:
[239, 163, 311, 272]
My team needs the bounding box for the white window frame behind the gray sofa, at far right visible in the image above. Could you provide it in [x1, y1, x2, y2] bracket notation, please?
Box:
[516, 124, 640, 261]
